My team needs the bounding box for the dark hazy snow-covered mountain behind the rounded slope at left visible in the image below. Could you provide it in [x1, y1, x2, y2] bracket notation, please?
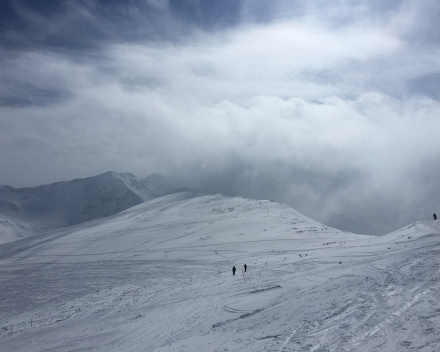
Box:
[0, 172, 182, 243]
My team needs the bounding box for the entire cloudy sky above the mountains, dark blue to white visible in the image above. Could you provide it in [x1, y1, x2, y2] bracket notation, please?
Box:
[0, 0, 440, 233]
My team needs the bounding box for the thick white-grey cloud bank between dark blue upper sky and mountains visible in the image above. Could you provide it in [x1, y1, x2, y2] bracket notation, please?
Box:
[0, 6, 440, 234]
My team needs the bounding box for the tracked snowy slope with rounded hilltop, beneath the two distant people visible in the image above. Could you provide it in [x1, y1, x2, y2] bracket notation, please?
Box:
[0, 192, 440, 352]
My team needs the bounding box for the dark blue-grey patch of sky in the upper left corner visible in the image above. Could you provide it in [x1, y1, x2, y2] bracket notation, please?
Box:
[0, 0, 241, 50]
